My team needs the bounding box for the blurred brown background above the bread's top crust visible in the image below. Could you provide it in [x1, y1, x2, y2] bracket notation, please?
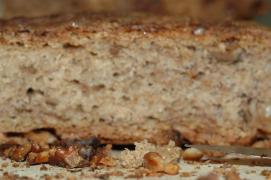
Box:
[0, 0, 271, 26]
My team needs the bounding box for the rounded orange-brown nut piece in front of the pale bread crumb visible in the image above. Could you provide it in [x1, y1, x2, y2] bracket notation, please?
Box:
[143, 152, 164, 172]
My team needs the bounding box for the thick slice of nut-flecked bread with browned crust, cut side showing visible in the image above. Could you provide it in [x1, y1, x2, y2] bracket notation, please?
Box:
[0, 14, 271, 145]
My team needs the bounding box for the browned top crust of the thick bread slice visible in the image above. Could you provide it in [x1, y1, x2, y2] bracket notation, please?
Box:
[0, 13, 271, 47]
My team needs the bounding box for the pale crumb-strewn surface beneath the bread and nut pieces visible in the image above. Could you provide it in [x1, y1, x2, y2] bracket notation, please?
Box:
[0, 152, 271, 180]
